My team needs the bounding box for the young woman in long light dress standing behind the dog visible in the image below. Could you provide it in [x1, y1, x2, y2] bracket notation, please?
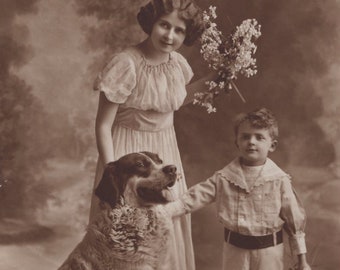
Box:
[90, 0, 214, 270]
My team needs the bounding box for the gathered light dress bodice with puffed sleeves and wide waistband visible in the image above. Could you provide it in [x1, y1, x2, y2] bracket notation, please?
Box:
[96, 46, 193, 131]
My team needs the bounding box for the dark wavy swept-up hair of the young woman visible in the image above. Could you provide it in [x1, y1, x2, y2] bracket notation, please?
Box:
[137, 0, 204, 46]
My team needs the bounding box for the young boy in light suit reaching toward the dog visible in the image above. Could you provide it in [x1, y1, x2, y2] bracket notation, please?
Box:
[170, 108, 311, 270]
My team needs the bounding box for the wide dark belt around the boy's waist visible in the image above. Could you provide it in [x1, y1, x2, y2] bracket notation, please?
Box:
[224, 228, 283, 249]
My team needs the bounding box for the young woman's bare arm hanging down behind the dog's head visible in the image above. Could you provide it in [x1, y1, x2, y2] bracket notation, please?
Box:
[95, 92, 119, 165]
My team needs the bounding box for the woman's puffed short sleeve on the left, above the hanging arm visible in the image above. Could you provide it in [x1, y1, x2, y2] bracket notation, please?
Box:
[94, 52, 136, 104]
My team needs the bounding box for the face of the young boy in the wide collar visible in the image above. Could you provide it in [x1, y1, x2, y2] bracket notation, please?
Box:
[236, 121, 277, 166]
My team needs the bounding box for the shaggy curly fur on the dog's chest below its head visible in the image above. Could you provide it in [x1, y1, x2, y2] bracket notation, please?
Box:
[89, 205, 172, 261]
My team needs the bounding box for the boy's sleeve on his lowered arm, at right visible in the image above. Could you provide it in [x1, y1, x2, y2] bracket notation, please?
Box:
[280, 178, 307, 255]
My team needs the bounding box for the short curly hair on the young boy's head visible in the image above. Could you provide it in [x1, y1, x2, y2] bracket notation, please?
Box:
[234, 108, 279, 140]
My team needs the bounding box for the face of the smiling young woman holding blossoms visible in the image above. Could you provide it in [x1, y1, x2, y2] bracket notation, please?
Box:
[150, 10, 186, 53]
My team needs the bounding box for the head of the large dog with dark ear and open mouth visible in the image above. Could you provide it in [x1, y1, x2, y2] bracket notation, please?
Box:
[95, 152, 177, 207]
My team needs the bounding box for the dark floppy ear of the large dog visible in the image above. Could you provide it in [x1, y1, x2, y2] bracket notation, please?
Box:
[94, 162, 121, 207]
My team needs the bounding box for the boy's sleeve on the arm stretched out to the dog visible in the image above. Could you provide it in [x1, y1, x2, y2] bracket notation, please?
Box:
[164, 174, 217, 217]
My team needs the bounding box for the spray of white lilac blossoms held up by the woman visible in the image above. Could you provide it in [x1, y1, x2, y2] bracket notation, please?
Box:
[193, 6, 261, 113]
